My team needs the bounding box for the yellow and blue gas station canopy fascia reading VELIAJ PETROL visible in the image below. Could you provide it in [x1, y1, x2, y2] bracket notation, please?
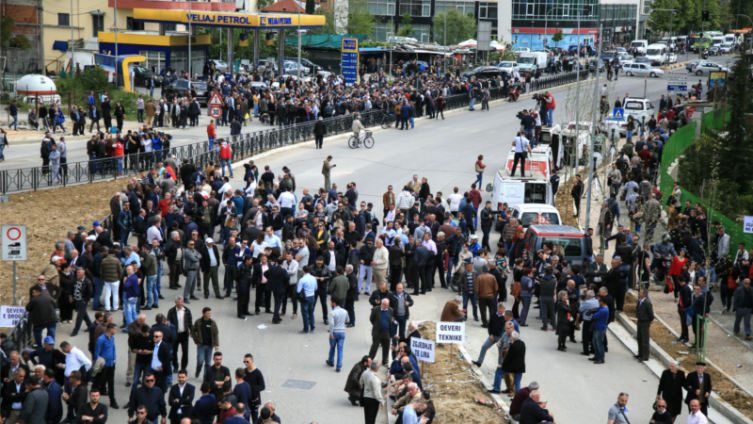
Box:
[133, 9, 325, 29]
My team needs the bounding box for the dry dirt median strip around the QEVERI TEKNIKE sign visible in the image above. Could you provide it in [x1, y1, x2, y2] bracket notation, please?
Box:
[419, 322, 504, 424]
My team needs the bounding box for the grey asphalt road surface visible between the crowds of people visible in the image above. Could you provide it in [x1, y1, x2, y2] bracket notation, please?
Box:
[47, 53, 740, 424]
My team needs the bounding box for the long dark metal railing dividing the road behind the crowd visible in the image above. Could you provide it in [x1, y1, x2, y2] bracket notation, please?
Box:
[0, 71, 590, 194]
